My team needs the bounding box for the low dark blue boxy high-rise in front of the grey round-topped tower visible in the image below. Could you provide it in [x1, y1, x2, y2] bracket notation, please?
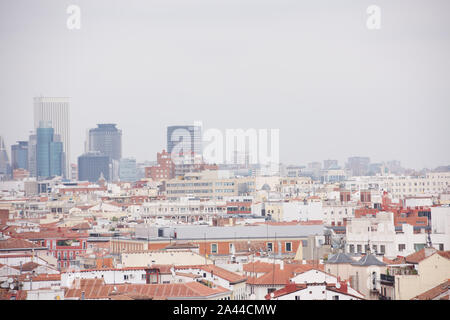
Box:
[78, 152, 112, 182]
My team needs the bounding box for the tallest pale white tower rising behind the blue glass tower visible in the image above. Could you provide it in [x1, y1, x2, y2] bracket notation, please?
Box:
[30, 97, 70, 178]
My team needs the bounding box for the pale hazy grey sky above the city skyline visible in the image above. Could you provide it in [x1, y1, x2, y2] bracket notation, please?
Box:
[0, 0, 450, 168]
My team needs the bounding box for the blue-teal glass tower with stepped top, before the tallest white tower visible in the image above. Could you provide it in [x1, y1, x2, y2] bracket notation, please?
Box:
[36, 121, 65, 179]
